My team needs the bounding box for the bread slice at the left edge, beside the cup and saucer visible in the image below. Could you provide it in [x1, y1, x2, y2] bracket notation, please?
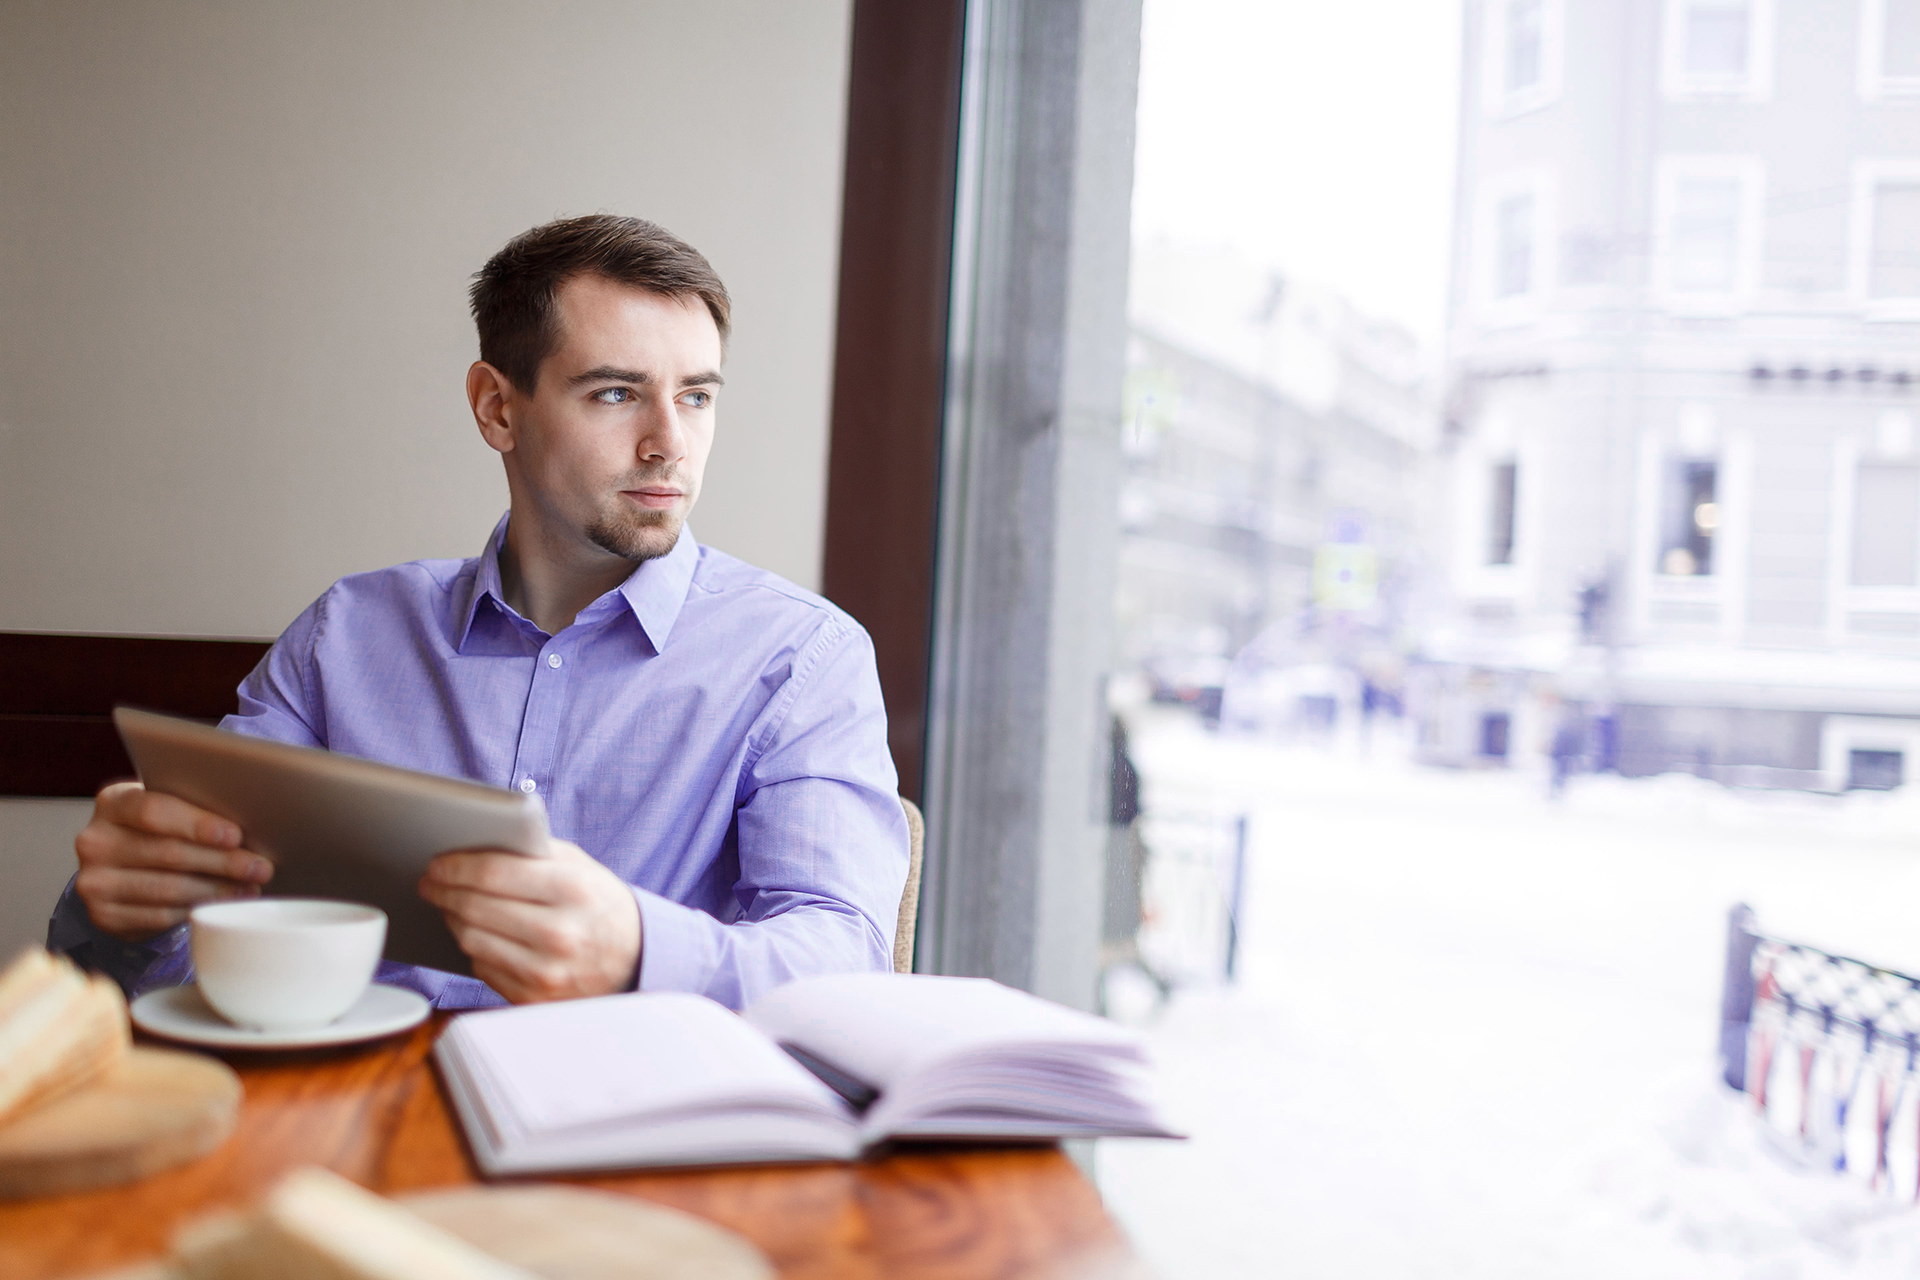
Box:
[0, 946, 131, 1125]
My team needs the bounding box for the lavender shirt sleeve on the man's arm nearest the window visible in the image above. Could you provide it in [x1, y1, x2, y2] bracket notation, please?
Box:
[634, 620, 908, 1009]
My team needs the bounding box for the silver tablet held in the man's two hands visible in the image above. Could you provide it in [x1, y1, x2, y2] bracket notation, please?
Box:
[113, 706, 547, 975]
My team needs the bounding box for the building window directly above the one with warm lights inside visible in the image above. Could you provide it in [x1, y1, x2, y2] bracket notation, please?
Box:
[1655, 155, 1761, 305]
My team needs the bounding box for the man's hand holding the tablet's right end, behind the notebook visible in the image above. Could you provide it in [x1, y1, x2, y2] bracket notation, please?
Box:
[420, 841, 641, 1004]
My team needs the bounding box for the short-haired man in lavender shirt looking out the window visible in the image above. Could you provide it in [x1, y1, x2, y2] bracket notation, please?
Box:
[48, 215, 906, 1007]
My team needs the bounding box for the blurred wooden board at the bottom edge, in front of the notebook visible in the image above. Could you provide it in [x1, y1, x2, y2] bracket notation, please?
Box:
[399, 1186, 774, 1280]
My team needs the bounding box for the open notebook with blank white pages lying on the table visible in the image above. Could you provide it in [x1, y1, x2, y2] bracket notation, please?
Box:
[434, 973, 1177, 1174]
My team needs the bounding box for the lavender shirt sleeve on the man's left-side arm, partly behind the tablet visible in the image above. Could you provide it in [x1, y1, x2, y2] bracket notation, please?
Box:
[46, 597, 326, 998]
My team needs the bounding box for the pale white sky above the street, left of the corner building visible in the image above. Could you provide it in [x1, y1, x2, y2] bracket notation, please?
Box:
[1133, 0, 1459, 349]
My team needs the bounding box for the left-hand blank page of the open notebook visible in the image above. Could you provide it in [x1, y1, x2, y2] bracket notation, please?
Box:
[447, 992, 849, 1132]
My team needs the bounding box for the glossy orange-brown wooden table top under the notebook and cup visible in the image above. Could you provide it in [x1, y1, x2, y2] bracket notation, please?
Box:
[0, 1015, 1139, 1280]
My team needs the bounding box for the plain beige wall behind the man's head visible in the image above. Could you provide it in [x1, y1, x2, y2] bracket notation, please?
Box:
[0, 0, 849, 955]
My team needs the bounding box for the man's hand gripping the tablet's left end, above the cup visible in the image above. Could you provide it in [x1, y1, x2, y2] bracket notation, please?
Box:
[73, 783, 273, 942]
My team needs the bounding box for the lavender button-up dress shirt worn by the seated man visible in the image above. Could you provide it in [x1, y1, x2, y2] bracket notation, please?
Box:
[48, 518, 906, 1007]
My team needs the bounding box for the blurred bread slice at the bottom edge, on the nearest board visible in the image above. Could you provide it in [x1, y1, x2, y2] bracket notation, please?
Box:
[173, 1169, 534, 1280]
